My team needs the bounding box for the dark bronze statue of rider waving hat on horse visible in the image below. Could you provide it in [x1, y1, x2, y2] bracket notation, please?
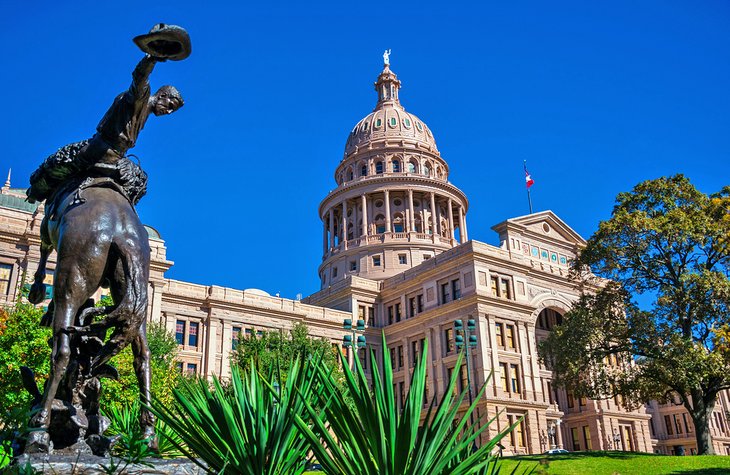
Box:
[23, 24, 191, 455]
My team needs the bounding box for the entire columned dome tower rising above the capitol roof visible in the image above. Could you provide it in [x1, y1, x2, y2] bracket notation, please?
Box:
[319, 64, 468, 288]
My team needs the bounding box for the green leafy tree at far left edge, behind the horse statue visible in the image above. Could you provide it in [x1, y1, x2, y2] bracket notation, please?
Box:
[0, 302, 51, 418]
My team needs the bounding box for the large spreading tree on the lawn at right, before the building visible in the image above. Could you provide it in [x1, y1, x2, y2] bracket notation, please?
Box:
[540, 175, 730, 454]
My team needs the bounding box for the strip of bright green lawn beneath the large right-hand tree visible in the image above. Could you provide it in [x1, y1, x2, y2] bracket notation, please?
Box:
[500, 452, 730, 475]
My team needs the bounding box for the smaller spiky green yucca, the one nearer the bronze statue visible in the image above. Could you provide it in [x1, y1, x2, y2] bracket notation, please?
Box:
[152, 360, 319, 475]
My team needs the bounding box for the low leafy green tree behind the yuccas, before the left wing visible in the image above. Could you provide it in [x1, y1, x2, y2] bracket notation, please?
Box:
[231, 322, 344, 383]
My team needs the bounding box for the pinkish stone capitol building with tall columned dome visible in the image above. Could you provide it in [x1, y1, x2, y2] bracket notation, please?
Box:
[0, 59, 730, 455]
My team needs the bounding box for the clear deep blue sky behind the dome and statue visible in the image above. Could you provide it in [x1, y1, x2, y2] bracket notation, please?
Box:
[0, 1, 730, 298]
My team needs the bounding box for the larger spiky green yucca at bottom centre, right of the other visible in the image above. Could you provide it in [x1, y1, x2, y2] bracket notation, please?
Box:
[295, 335, 528, 475]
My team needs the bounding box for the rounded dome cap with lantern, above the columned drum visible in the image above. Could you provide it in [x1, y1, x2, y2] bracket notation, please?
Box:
[345, 65, 438, 157]
